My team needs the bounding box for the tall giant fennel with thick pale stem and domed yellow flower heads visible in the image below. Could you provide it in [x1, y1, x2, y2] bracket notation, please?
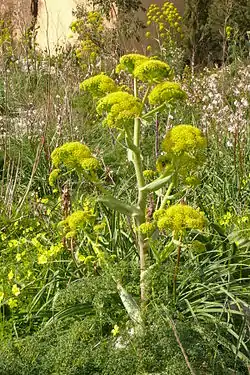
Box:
[50, 54, 206, 328]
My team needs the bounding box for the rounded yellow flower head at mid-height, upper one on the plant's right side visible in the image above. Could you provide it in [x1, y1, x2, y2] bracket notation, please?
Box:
[162, 125, 206, 154]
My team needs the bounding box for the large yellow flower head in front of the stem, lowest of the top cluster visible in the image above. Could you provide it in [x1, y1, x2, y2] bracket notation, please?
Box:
[96, 91, 142, 128]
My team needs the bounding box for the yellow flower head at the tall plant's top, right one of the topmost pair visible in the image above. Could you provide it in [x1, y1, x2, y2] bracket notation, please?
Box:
[134, 59, 171, 83]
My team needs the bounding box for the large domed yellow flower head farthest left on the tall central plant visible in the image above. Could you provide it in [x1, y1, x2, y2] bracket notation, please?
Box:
[51, 142, 99, 172]
